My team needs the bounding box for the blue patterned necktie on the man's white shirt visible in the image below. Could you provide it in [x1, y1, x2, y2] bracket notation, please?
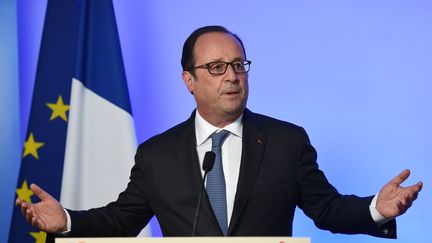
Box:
[206, 130, 229, 235]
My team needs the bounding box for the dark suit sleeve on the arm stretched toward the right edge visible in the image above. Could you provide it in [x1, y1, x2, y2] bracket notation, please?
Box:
[297, 130, 396, 238]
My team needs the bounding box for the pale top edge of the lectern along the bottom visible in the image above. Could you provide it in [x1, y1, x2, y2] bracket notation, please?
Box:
[56, 236, 310, 243]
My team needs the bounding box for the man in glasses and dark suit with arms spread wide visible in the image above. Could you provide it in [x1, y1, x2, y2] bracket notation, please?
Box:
[17, 26, 422, 238]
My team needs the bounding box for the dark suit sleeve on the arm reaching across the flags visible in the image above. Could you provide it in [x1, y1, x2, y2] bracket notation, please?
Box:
[68, 146, 153, 237]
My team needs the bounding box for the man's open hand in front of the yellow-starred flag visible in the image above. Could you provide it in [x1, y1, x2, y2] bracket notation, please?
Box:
[16, 184, 67, 233]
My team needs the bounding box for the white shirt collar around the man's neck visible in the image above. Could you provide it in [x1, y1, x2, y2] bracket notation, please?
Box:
[195, 109, 243, 146]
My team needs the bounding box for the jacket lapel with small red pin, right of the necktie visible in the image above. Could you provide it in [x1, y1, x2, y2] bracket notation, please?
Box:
[228, 109, 266, 235]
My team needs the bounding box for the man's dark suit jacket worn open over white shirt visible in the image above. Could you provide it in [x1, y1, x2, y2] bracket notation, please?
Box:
[63, 110, 396, 238]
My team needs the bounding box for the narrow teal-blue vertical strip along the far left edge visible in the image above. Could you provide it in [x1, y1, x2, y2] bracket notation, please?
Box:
[0, 0, 21, 242]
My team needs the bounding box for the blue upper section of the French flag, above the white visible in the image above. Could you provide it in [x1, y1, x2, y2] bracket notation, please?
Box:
[75, 0, 132, 114]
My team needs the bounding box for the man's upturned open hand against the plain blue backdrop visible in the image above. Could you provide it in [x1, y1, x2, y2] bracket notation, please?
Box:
[376, 170, 423, 218]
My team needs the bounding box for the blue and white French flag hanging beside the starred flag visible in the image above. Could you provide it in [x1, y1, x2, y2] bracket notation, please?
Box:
[60, 0, 148, 235]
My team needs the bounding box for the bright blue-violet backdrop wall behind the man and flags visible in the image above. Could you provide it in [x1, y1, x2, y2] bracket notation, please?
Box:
[0, 0, 432, 243]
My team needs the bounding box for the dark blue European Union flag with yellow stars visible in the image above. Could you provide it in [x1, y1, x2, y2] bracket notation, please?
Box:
[9, 0, 79, 243]
